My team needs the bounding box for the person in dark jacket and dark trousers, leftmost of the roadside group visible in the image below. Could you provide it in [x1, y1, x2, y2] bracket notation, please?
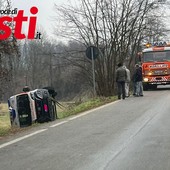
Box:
[116, 63, 127, 99]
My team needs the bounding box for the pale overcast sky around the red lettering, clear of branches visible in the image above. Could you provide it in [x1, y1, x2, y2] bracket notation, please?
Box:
[11, 0, 73, 36]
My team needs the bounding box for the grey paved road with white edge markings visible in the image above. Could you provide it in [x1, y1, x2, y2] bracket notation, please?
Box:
[0, 89, 170, 170]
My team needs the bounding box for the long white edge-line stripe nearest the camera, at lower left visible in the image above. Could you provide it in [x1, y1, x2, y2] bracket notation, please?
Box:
[0, 129, 47, 149]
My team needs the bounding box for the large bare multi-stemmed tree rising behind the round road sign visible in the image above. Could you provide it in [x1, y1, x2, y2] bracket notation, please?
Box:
[55, 0, 167, 96]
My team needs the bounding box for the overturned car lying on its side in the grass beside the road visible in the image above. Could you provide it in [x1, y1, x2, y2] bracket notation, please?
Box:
[8, 88, 57, 127]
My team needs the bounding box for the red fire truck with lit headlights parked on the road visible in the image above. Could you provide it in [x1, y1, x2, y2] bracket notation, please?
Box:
[141, 42, 170, 90]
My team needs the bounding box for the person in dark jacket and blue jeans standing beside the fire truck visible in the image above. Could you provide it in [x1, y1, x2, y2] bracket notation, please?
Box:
[134, 64, 143, 97]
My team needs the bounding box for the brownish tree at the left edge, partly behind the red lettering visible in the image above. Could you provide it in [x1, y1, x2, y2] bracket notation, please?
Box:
[0, 0, 19, 100]
